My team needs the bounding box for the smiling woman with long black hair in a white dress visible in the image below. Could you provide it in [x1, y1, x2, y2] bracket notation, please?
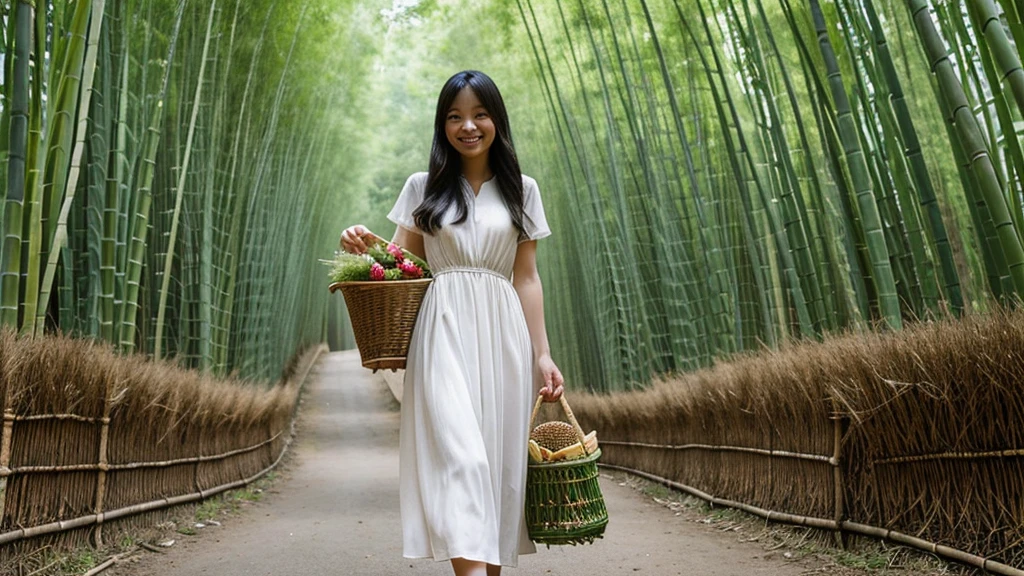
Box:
[342, 71, 562, 576]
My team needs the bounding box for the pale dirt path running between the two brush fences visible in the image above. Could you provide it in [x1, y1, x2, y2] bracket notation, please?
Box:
[111, 353, 807, 576]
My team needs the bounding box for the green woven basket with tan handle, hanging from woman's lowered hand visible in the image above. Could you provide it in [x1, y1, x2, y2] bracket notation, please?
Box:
[526, 397, 608, 547]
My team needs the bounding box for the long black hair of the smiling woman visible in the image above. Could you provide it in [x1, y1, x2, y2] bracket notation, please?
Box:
[413, 70, 525, 237]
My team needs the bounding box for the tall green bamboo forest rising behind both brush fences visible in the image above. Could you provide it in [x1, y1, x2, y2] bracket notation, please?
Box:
[0, 0, 1024, 390]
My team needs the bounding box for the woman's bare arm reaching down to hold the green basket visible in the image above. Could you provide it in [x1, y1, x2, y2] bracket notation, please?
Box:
[512, 240, 563, 402]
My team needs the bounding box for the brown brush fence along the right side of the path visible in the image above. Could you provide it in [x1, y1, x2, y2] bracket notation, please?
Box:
[573, 312, 1024, 575]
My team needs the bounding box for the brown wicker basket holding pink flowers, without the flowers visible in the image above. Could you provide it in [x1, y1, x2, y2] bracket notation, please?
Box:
[329, 278, 431, 372]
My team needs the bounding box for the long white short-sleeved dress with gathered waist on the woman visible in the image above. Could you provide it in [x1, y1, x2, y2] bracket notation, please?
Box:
[388, 172, 551, 567]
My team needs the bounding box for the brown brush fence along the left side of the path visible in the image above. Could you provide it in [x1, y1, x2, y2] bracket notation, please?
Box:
[0, 332, 322, 572]
